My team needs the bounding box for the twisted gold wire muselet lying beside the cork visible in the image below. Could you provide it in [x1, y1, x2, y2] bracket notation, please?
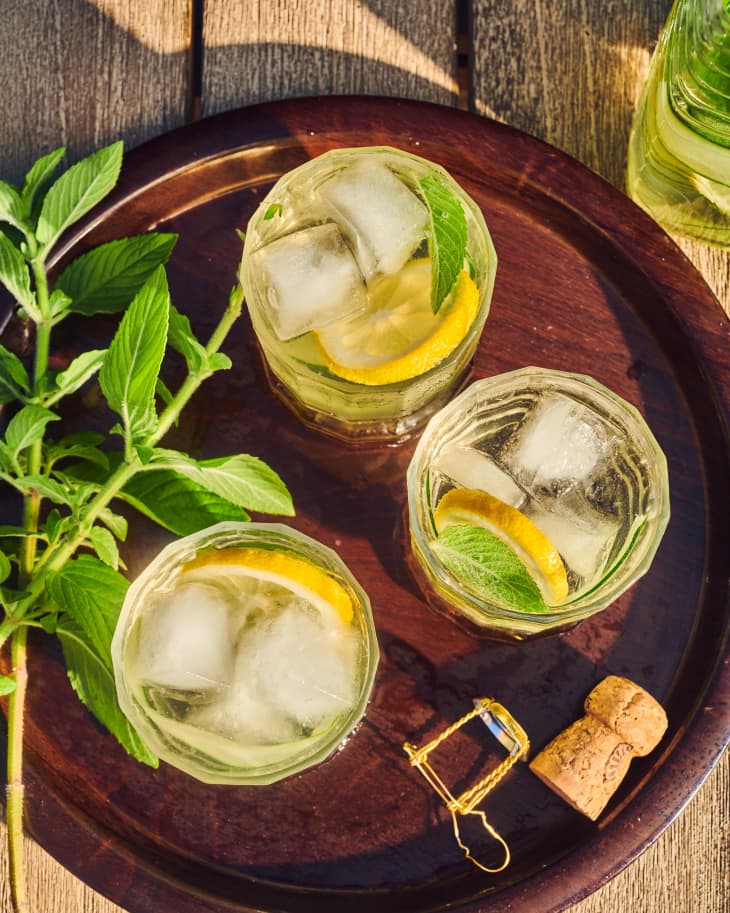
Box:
[403, 697, 530, 873]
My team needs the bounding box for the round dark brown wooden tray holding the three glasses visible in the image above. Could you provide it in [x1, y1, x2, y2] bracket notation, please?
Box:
[1, 98, 730, 913]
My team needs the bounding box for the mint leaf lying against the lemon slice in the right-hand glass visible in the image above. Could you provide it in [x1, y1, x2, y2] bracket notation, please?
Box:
[432, 526, 550, 613]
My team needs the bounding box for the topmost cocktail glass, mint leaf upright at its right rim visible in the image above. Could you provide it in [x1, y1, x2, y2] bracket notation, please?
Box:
[241, 147, 497, 442]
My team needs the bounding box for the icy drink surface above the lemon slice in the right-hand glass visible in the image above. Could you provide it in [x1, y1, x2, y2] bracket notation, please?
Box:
[429, 390, 650, 601]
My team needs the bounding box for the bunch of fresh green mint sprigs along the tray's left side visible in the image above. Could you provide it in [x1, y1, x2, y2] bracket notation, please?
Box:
[0, 143, 294, 910]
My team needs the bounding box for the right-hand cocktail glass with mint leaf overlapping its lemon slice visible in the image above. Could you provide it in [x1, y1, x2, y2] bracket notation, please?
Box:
[408, 367, 669, 638]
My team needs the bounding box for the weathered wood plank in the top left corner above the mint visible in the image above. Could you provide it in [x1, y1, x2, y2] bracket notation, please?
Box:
[0, 0, 191, 180]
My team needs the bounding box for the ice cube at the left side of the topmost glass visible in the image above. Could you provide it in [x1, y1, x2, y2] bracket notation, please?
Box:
[251, 222, 367, 340]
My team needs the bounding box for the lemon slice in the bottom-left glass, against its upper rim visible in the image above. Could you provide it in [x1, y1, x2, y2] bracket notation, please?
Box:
[181, 547, 353, 625]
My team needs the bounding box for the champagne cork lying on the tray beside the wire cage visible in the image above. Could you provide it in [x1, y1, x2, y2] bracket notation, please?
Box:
[530, 675, 667, 821]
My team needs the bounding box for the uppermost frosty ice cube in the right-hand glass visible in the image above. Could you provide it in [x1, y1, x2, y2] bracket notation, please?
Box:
[500, 394, 614, 493]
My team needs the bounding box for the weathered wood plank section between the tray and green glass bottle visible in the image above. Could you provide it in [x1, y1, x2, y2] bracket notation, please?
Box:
[472, 0, 671, 185]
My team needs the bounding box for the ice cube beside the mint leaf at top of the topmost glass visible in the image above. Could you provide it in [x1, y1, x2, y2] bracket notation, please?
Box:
[320, 158, 428, 281]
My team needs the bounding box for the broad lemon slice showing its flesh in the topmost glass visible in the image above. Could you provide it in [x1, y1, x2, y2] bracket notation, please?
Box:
[316, 259, 479, 386]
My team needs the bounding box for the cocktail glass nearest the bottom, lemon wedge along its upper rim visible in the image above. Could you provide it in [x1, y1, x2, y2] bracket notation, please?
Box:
[112, 522, 379, 784]
